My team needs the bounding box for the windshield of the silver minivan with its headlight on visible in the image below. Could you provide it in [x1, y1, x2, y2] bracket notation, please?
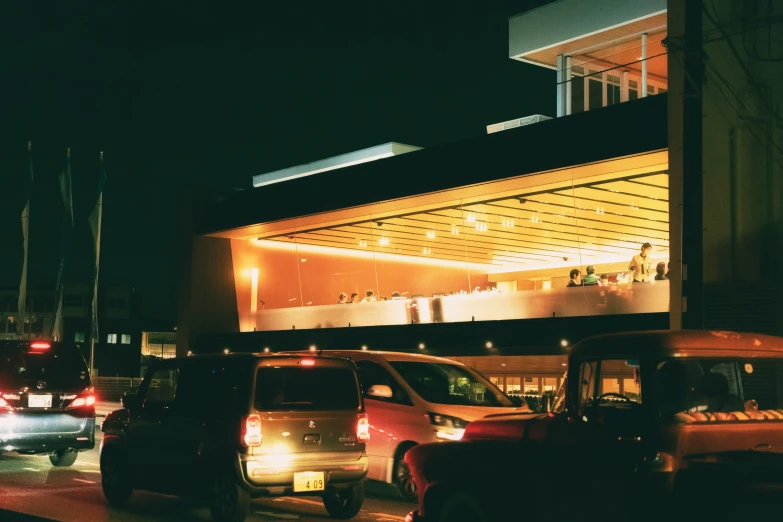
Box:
[389, 361, 515, 408]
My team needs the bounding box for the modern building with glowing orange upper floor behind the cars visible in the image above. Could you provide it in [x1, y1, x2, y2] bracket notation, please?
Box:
[177, 0, 783, 386]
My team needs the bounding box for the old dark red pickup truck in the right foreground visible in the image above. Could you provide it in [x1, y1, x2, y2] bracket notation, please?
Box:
[405, 331, 783, 522]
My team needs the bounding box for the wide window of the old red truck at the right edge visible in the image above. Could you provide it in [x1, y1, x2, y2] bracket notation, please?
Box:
[657, 357, 783, 422]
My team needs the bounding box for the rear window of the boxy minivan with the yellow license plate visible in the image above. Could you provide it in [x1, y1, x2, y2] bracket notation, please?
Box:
[256, 366, 359, 411]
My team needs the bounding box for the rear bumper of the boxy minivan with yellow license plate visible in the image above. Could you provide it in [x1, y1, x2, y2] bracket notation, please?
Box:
[237, 453, 369, 496]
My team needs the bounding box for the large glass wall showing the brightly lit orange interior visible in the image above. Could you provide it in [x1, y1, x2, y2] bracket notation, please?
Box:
[232, 152, 669, 330]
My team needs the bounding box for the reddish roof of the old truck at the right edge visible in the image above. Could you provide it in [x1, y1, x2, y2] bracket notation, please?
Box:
[569, 330, 783, 358]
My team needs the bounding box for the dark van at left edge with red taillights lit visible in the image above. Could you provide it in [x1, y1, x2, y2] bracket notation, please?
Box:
[0, 341, 95, 466]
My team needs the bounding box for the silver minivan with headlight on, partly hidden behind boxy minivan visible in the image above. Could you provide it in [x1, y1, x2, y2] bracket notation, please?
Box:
[284, 350, 530, 501]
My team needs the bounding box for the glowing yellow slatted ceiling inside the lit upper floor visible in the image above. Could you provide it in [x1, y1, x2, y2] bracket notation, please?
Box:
[264, 172, 669, 270]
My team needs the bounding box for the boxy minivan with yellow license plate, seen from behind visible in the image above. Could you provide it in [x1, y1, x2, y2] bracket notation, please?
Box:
[100, 354, 369, 521]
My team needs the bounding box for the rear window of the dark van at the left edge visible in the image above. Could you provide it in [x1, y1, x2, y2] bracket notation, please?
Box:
[0, 341, 90, 389]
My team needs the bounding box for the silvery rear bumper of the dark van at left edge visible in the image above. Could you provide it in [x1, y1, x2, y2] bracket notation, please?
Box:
[0, 412, 95, 453]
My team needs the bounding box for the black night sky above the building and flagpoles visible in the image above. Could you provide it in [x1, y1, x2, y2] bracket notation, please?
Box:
[0, 0, 555, 322]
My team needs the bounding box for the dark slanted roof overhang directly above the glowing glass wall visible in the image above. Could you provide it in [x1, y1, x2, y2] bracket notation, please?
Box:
[197, 95, 667, 239]
